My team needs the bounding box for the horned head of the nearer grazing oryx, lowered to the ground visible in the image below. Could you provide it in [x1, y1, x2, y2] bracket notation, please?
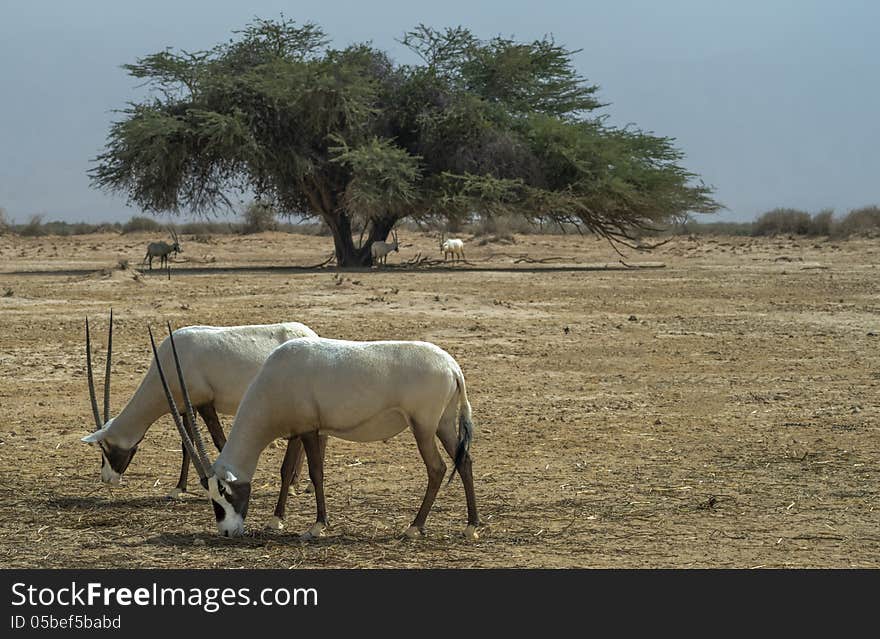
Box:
[148, 323, 251, 537]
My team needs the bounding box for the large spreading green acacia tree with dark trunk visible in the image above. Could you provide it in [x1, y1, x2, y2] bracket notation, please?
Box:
[90, 16, 719, 266]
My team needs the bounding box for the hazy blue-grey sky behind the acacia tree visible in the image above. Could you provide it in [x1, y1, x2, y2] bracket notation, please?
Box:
[0, 0, 880, 221]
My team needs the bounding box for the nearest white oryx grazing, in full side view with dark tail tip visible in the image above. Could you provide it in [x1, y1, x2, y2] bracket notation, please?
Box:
[150, 331, 479, 539]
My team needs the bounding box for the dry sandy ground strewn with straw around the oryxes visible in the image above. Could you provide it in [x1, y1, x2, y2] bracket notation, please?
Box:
[0, 233, 880, 568]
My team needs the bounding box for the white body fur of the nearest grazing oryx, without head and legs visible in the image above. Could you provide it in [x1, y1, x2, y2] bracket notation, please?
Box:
[206, 337, 471, 536]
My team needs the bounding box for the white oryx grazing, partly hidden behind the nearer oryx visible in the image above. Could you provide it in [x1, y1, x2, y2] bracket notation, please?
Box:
[82, 311, 317, 528]
